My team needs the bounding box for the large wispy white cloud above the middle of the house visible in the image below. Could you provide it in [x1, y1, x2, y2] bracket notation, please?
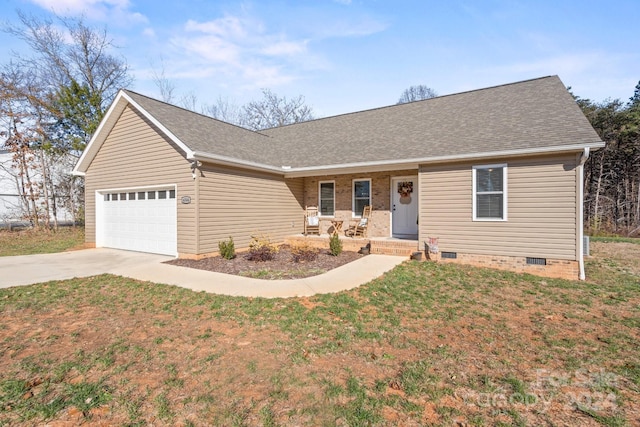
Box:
[141, 9, 386, 97]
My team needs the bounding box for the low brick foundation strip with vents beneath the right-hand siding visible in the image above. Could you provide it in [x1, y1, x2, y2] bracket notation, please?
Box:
[429, 252, 580, 280]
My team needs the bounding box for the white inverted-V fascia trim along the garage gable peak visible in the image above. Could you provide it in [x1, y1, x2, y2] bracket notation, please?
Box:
[72, 90, 193, 176]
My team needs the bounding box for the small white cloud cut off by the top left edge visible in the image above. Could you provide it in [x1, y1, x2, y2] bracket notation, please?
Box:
[30, 0, 148, 24]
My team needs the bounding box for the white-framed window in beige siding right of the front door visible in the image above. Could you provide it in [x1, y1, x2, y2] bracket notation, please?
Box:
[473, 164, 507, 221]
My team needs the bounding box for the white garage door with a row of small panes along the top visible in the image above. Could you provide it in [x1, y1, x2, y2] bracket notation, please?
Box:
[96, 187, 177, 255]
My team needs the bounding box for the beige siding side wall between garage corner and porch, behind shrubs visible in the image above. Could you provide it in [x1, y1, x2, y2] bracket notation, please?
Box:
[198, 164, 304, 254]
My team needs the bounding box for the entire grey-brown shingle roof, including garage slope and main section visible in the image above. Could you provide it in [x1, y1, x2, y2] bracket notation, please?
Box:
[126, 76, 601, 169]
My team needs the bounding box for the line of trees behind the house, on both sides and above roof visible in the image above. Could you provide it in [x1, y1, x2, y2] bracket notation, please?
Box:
[0, 13, 640, 235]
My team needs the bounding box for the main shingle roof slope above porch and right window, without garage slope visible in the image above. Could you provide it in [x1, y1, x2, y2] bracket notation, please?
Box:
[262, 76, 600, 167]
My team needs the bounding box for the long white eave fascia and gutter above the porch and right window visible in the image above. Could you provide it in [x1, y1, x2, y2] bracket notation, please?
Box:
[285, 141, 605, 178]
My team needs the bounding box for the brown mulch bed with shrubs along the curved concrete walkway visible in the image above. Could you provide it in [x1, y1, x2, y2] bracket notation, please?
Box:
[166, 245, 364, 279]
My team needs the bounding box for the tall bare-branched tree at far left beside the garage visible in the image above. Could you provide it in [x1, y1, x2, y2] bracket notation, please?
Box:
[0, 12, 131, 227]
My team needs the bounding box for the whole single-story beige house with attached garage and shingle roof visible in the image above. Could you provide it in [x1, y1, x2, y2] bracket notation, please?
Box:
[74, 76, 604, 279]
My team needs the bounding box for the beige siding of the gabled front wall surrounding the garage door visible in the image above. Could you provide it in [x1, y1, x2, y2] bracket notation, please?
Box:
[85, 106, 196, 253]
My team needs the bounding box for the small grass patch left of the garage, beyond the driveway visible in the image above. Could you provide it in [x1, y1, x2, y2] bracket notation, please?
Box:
[0, 227, 84, 256]
